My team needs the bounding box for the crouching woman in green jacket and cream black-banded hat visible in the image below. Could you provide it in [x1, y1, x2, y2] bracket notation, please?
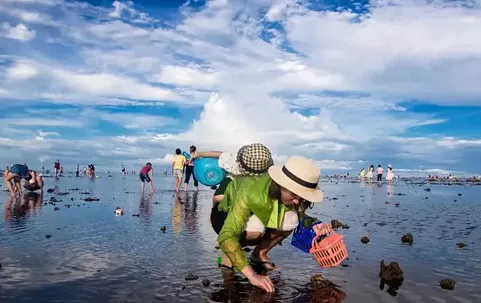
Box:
[212, 157, 323, 292]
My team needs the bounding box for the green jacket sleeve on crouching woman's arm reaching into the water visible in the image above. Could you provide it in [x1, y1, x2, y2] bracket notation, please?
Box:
[217, 186, 251, 271]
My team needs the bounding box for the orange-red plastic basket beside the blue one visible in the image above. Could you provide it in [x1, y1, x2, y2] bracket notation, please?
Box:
[309, 232, 348, 268]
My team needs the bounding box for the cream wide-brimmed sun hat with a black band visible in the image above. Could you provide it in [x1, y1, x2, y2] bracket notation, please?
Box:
[269, 156, 324, 202]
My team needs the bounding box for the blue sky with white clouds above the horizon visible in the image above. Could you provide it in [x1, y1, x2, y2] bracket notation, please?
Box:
[0, 0, 481, 175]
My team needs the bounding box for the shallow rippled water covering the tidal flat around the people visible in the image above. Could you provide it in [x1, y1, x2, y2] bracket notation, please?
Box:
[0, 175, 481, 303]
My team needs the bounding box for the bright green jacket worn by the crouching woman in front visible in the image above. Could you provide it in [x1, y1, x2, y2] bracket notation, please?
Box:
[217, 175, 289, 271]
